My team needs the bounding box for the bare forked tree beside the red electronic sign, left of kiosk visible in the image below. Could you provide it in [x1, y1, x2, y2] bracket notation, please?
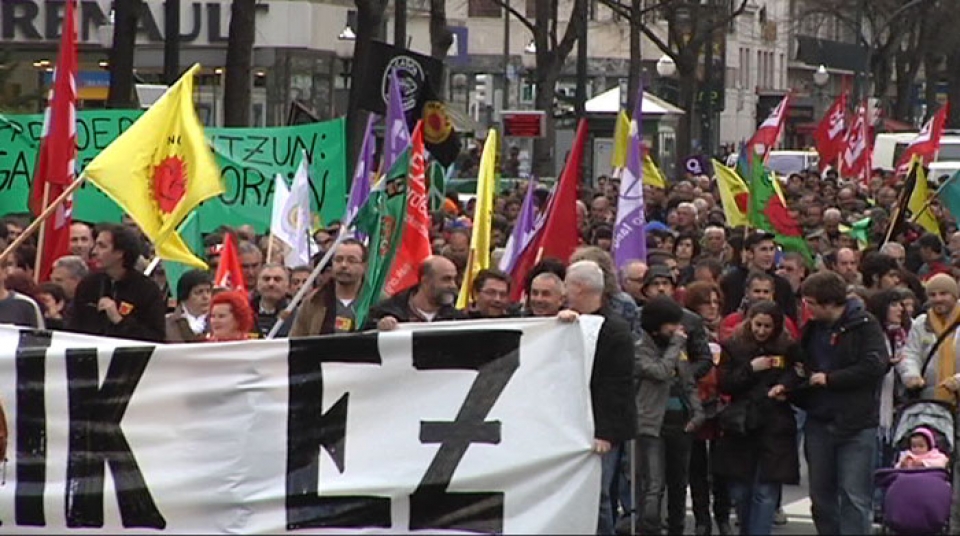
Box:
[491, 0, 587, 177]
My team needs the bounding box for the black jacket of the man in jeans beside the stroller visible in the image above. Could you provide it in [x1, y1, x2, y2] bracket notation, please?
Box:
[788, 306, 890, 434]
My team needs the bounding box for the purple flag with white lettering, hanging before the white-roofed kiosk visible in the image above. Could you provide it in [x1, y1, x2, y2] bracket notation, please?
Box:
[613, 85, 647, 270]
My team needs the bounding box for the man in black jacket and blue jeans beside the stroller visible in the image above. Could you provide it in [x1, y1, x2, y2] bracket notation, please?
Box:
[770, 272, 890, 534]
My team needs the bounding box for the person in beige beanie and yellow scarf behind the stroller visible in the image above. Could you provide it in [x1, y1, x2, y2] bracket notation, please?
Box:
[897, 274, 960, 404]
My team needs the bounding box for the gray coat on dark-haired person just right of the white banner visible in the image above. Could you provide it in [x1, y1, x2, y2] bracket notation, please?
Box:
[633, 330, 704, 437]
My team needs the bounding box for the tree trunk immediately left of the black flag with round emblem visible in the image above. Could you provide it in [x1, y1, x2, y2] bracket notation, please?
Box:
[346, 0, 387, 171]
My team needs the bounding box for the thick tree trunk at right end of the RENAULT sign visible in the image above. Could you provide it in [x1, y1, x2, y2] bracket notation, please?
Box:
[223, 0, 257, 127]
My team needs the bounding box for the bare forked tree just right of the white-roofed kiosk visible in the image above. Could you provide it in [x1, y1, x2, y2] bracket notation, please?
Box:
[600, 0, 749, 156]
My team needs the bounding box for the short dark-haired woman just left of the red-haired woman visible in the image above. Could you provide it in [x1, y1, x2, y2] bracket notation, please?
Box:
[166, 270, 213, 342]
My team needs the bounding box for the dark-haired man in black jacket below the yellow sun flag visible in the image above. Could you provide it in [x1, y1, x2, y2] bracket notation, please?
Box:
[67, 225, 167, 342]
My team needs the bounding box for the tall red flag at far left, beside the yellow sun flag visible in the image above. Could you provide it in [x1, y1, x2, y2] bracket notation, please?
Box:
[30, 0, 77, 281]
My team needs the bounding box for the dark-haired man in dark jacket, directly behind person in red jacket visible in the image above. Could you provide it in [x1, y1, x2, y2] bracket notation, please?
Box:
[720, 231, 797, 320]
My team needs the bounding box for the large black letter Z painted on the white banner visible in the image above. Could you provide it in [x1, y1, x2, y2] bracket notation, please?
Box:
[410, 330, 521, 534]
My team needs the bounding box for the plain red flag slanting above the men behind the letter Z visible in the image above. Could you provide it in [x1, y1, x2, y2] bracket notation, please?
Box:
[510, 119, 587, 300]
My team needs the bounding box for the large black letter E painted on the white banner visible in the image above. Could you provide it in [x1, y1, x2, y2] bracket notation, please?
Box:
[287, 333, 391, 530]
